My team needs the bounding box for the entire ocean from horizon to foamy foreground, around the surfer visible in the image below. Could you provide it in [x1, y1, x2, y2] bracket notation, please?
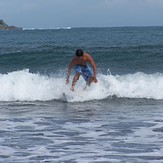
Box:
[0, 27, 163, 163]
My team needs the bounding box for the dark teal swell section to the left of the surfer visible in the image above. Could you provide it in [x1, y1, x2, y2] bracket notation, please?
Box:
[0, 45, 72, 73]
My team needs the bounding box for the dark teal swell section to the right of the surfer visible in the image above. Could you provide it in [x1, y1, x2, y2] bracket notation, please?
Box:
[91, 45, 163, 74]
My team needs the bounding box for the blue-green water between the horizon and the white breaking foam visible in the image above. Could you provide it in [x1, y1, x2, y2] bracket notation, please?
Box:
[0, 27, 163, 74]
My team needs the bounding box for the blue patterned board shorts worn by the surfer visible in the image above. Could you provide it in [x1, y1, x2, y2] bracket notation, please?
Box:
[74, 64, 93, 82]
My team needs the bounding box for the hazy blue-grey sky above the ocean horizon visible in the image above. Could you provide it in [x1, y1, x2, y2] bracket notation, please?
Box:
[0, 0, 163, 28]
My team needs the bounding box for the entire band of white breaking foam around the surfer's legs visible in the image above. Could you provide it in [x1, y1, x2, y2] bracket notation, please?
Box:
[0, 70, 163, 102]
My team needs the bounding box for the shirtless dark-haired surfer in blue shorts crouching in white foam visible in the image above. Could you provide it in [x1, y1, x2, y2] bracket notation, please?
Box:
[66, 49, 97, 91]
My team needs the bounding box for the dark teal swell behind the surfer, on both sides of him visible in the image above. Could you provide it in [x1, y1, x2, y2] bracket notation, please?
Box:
[0, 44, 163, 74]
